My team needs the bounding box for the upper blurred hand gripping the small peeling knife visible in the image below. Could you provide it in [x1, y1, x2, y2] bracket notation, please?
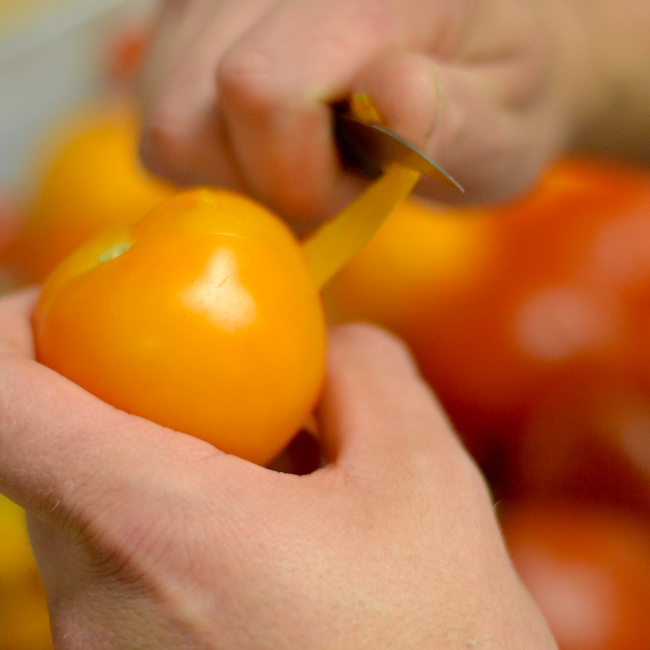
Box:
[142, 0, 593, 231]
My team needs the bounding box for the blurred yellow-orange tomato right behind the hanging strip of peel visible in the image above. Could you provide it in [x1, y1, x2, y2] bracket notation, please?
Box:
[324, 199, 495, 336]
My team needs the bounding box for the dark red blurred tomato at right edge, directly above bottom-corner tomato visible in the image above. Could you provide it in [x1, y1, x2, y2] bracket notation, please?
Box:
[508, 372, 650, 513]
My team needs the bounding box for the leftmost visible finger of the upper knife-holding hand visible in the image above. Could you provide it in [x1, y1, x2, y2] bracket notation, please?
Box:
[140, 0, 272, 189]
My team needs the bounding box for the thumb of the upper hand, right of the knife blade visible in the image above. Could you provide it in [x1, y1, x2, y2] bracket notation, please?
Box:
[354, 53, 559, 203]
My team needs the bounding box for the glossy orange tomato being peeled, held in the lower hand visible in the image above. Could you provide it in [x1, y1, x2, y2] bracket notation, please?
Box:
[34, 185, 325, 464]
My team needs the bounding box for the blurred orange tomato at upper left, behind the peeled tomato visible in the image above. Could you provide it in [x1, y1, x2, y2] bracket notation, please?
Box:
[24, 102, 176, 282]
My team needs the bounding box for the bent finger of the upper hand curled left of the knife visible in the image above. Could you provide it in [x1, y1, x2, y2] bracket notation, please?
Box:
[218, 0, 406, 223]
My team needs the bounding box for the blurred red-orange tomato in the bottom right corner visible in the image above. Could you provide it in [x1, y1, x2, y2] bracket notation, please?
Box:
[502, 502, 650, 650]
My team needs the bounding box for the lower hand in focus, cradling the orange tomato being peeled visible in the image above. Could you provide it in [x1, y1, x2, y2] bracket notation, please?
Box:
[0, 293, 555, 650]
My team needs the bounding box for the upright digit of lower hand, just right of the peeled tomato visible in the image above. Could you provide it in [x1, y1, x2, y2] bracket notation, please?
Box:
[319, 325, 465, 477]
